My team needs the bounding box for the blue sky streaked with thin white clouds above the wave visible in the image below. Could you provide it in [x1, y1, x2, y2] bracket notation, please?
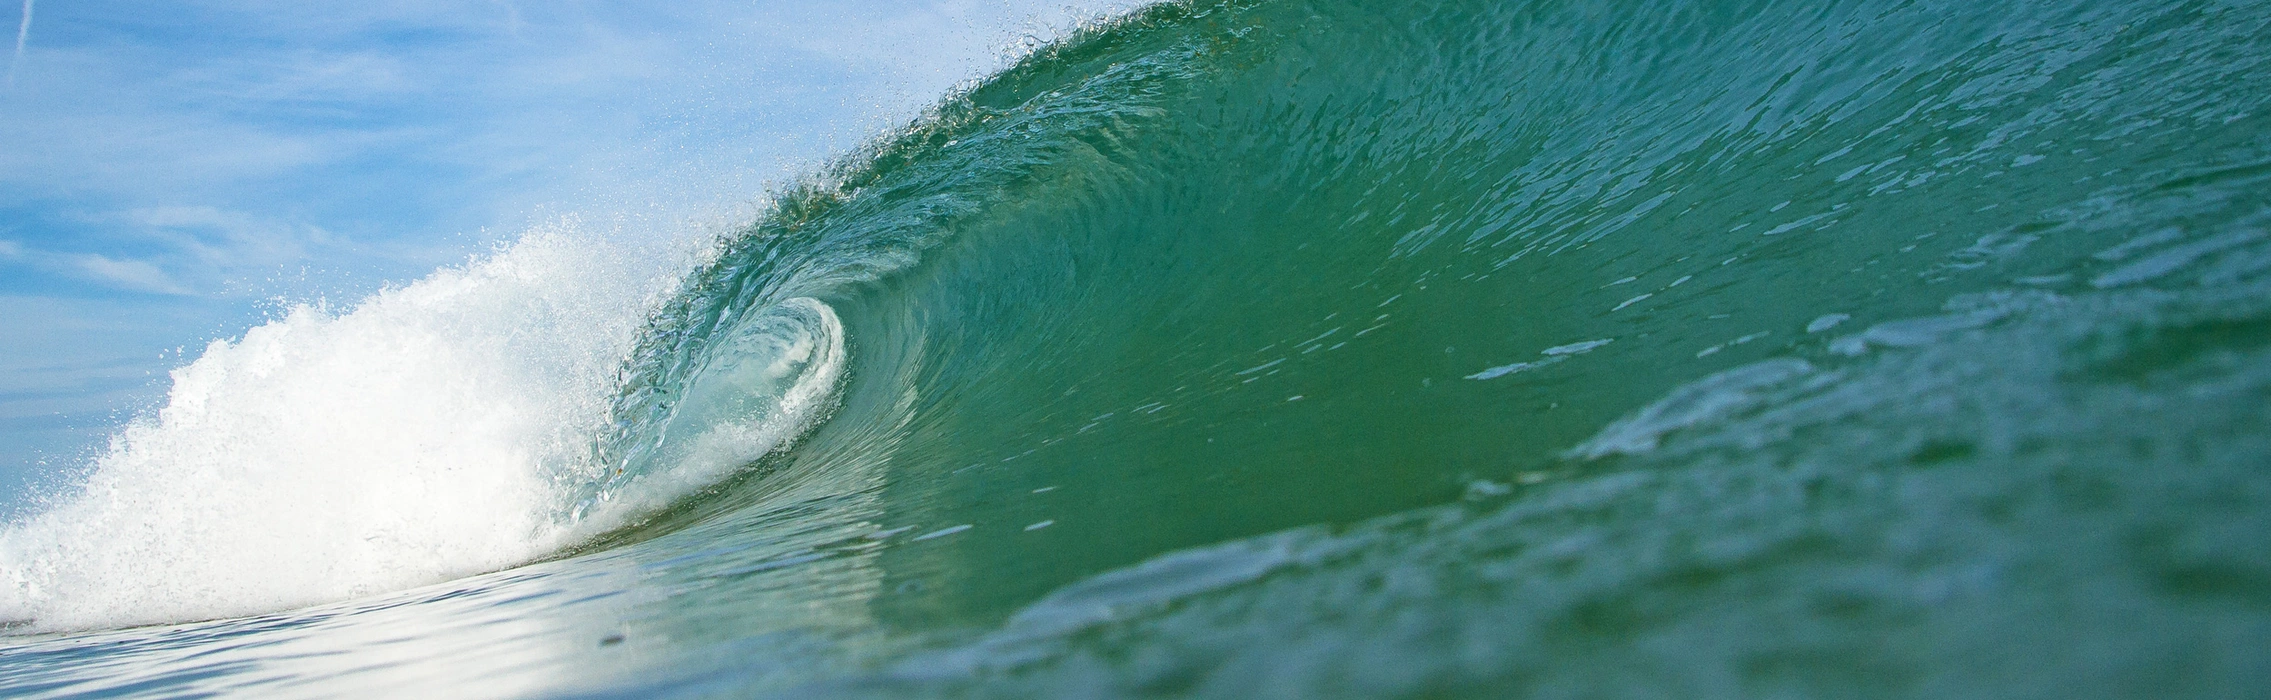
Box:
[0, 0, 1126, 500]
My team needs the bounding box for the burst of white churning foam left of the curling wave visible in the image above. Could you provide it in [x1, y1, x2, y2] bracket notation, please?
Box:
[0, 227, 693, 630]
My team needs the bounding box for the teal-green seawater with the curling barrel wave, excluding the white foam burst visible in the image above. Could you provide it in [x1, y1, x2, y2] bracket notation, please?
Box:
[0, 0, 2271, 698]
